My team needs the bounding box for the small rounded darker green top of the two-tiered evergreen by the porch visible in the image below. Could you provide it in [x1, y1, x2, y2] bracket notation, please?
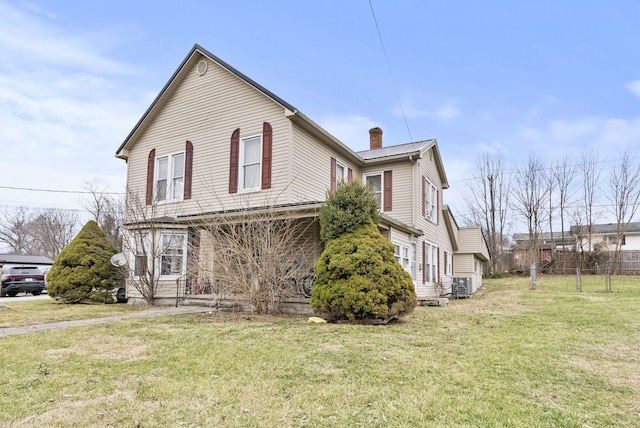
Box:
[320, 180, 380, 242]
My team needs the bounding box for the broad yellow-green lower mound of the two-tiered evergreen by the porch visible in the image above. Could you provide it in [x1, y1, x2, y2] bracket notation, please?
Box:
[311, 223, 417, 321]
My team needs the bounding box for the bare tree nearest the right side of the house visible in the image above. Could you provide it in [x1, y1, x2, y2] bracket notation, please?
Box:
[464, 154, 510, 272]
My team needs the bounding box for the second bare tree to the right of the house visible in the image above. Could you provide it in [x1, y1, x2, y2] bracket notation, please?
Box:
[512, 153, 548, 263]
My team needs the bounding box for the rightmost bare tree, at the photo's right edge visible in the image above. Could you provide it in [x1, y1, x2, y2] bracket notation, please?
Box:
[606, 147, 640, 271]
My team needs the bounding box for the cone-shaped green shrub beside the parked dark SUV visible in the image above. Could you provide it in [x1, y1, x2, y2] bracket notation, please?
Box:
[47, 220, 116, 303]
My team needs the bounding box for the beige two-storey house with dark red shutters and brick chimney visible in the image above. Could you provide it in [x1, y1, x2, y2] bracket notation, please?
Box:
[116, 45, 488, 303]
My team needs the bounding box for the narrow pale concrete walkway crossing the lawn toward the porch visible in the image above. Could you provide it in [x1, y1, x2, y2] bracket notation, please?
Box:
[0, 306, 211, 337]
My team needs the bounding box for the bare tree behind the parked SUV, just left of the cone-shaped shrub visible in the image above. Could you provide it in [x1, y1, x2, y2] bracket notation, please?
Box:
[29, 208, 80, 260]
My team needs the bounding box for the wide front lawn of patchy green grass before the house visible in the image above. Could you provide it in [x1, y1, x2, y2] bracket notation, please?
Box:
[0, 277, 640, 427]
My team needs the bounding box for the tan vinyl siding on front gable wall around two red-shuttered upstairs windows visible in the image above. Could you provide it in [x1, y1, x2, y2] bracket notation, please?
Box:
[127, 53, 291, 219]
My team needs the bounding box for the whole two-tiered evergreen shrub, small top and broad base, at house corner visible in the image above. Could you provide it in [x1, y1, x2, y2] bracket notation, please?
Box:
[310, 182, 417, 322]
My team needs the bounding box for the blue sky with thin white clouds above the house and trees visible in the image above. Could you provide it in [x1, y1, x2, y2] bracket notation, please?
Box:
[0, 0, 640, 224]
